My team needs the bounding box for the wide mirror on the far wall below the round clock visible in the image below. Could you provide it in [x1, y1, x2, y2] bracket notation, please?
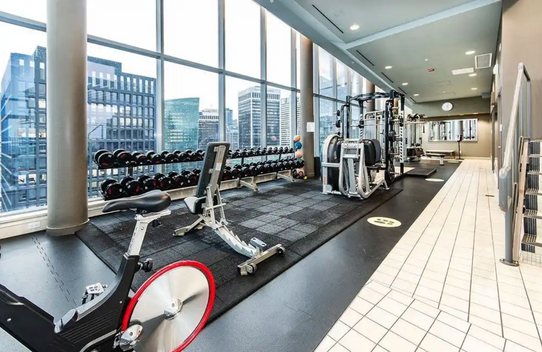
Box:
[429, 119, 478, 142]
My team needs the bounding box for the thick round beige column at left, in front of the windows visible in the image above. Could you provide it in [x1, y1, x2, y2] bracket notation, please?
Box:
[46, 0, 88, 235]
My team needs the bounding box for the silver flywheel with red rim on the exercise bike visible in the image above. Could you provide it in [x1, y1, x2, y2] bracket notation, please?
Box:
[122, 261, 215, 352]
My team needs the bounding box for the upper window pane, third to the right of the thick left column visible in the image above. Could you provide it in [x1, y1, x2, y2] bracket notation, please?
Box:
[224, 0, 261, 77]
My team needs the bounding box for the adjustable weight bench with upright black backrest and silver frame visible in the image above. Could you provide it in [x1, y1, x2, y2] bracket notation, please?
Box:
[174, 142, 284, 276]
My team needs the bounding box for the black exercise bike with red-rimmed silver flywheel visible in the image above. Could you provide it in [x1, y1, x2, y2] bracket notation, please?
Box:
[0, 191, 215, 352]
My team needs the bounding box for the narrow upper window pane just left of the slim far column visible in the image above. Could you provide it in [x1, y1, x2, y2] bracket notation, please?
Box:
[266, 12, 292, 86]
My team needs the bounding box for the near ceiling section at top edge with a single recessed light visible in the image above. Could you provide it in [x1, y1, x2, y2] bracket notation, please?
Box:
[296, 0, 473, 43]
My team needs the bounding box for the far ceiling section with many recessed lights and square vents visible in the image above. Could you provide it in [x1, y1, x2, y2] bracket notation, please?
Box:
[349, 3, 501, 102]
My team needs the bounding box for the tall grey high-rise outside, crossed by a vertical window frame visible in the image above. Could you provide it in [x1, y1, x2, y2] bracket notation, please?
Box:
[238, 86, 280, 148]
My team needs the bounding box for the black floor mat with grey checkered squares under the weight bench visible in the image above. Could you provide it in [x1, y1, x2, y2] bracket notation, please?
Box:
[78, 180, 402, 320]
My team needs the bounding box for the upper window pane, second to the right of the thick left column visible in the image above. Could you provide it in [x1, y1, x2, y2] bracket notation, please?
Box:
[164, 0, 218, 67]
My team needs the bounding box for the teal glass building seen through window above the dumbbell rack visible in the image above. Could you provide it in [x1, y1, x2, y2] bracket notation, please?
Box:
[164, 98, 199, 151]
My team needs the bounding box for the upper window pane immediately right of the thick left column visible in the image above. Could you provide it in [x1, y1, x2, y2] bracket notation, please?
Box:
[86, 0, 155, 50]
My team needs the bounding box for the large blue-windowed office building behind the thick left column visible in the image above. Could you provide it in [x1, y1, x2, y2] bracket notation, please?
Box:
[0, 47, 156, 211]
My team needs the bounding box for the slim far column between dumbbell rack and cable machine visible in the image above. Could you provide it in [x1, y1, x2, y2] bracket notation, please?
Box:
[299, 35, 314, 177]
